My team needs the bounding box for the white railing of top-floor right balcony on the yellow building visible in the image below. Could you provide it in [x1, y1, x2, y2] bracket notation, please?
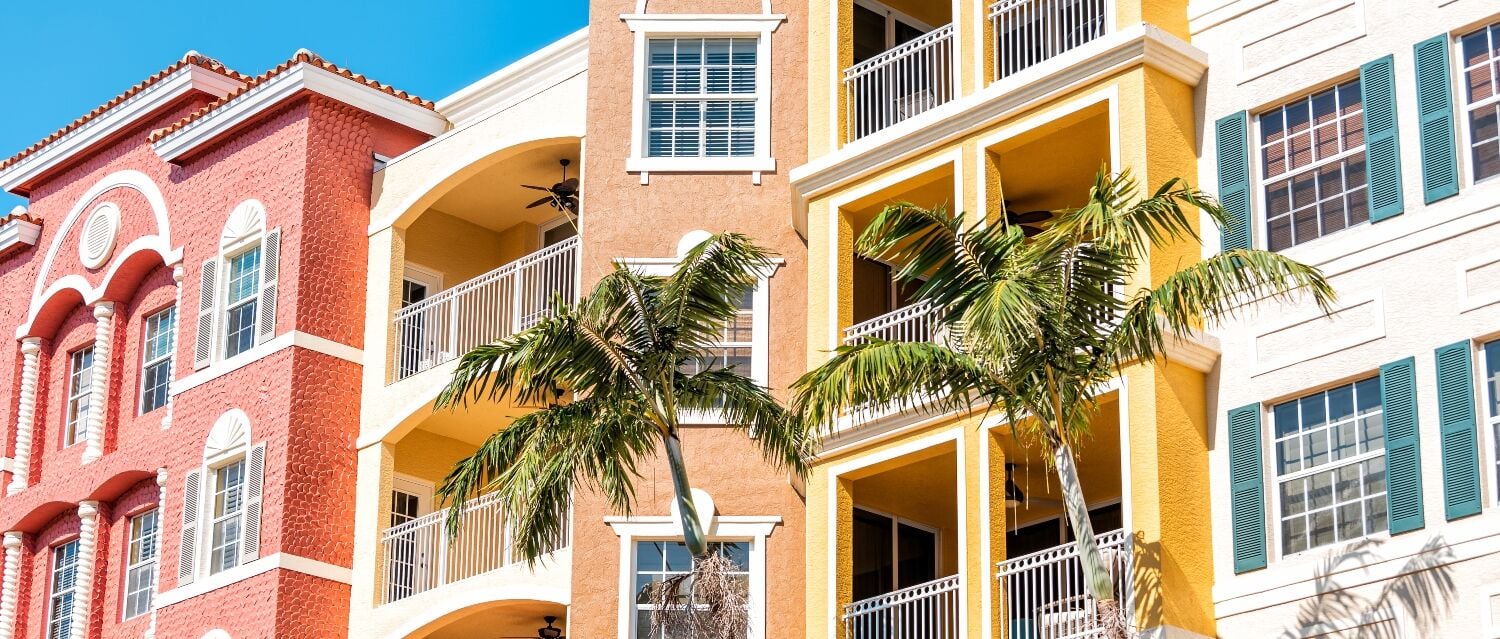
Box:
[990, 0, 1110, 80]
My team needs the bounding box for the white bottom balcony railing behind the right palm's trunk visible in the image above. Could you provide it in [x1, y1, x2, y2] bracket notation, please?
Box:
[996, 530, 1133, 639]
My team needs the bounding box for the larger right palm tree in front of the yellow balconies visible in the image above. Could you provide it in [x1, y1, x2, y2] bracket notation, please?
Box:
[794, 171, 1334, 636]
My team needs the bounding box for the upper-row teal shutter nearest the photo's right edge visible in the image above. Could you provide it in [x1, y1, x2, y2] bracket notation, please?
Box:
[1416, 33, 1458, 204]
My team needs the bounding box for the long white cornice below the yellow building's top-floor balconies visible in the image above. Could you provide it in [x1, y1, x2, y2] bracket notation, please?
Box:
[791, 24, 1208, 217]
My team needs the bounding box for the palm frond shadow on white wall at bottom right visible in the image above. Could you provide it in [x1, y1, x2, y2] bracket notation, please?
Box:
[1281, 536, 1457, 639]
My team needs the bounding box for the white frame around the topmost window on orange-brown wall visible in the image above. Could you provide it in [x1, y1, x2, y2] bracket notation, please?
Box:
[620, 14, 786, 185]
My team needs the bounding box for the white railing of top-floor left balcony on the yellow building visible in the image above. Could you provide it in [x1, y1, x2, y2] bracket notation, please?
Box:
[843, 24, 957, 141]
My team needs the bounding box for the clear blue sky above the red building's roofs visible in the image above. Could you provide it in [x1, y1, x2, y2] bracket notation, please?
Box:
[0, 0, 588, 215]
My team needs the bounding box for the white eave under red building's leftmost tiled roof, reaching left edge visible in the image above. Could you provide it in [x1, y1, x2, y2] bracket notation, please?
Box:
[0, 65, 245, 194]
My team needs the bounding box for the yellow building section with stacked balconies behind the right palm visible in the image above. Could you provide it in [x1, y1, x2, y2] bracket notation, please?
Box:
[792, 0, 1217, 638]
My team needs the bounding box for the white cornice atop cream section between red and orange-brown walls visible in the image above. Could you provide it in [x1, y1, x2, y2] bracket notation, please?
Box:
[438, 27, 588, 129]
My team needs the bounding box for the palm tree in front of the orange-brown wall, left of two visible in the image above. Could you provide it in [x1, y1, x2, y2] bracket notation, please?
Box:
[437, 233, 810, 561]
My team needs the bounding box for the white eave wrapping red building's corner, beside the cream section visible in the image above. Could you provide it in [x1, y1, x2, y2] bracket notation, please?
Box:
[152, 63, 449, 162]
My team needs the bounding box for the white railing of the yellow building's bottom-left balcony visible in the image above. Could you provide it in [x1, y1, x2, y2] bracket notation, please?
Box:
[843, 575, 960, 639]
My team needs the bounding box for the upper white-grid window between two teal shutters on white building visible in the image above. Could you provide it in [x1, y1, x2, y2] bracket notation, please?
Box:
[1259, 80, 1370, 251]
